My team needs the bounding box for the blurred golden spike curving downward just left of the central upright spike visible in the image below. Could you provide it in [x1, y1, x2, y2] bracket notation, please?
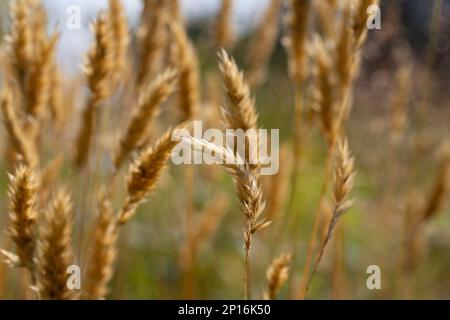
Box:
[170, 23, 200, 122]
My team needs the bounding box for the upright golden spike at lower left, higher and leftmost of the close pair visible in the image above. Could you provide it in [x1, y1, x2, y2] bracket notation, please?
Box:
[8, 165, 38, 275]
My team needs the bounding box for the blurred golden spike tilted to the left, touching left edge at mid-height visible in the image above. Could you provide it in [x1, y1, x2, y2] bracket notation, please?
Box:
[0, 89, 39, 167]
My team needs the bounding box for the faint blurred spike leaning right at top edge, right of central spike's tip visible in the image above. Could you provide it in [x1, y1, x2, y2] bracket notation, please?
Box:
[247, 0, 283, 86]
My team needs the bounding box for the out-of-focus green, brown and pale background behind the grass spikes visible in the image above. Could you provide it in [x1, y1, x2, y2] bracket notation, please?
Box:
[0, 0, 450, 299]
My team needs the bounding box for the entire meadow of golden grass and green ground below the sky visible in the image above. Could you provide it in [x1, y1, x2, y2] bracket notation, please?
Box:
[0, 0, 450, 299]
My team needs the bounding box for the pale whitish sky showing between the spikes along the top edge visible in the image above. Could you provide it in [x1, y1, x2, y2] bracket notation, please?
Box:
[43, 0, 268, 71]
